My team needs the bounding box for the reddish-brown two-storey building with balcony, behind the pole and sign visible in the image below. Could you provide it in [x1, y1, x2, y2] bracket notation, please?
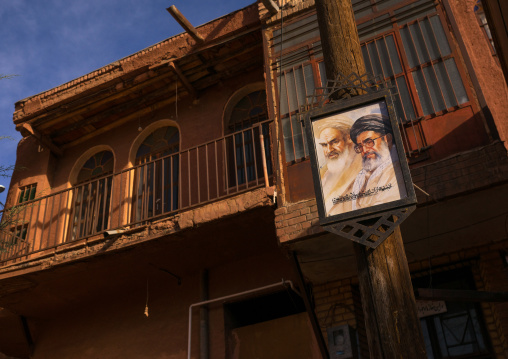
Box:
[0, 0, 508, 359]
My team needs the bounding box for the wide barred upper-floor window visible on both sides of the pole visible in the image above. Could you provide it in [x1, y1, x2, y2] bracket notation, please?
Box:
[272, 0, 469, 163]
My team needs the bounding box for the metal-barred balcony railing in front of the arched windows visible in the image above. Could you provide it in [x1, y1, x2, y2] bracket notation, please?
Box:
[0, 121, 273, 264]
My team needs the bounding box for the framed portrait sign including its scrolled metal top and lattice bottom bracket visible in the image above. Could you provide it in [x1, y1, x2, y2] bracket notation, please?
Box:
[304, 74, 416, 248]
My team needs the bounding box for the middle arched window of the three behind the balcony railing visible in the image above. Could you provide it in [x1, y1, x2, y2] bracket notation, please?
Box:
[133, 126, 180, 221]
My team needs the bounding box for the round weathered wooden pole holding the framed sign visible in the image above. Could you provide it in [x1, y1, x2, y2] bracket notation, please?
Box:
[315, 0, 427, 359]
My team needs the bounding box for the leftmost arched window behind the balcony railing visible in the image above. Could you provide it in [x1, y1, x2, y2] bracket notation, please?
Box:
[69, 151, 114, 240]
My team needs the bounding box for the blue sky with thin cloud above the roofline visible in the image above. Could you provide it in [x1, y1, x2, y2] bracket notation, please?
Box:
[0, 0, 255, 203]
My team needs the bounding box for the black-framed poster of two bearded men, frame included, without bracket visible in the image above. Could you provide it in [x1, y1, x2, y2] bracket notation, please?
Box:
[306, 92, 416, 223]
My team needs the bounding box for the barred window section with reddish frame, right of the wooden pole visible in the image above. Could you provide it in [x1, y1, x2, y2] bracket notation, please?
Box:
[362, 15, 469, 121]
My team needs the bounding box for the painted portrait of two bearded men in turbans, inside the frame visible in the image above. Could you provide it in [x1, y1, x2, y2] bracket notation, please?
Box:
[313, 103, 407, 216]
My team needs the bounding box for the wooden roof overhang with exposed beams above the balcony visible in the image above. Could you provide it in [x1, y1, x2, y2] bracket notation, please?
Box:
[14, 4, 263, 155]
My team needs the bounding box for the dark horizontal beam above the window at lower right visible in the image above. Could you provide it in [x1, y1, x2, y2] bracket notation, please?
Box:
[416, 288, 508, 302]
